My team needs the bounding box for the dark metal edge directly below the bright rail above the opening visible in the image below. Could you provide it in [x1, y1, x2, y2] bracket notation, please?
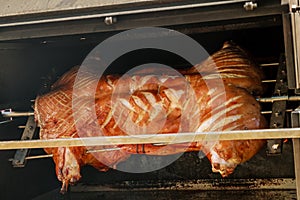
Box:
[0, 0, 288, 41]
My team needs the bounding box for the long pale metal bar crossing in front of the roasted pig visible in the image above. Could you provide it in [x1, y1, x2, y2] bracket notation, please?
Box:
[0, 128, 300, 150]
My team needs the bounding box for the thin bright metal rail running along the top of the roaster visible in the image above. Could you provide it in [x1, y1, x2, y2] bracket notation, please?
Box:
[0, 0, 247, 27]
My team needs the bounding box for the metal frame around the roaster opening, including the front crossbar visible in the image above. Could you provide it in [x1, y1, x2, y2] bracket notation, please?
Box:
[0, 0, 300, 199]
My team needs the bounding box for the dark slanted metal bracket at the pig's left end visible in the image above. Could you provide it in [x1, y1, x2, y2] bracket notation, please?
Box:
[12, 116, 36, 167]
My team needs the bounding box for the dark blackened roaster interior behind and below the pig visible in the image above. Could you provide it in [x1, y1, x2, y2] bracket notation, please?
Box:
[0, 5, 298, 199]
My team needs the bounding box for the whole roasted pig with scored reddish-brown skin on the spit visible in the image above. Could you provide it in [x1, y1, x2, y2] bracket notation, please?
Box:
[35, 42, 266, 191]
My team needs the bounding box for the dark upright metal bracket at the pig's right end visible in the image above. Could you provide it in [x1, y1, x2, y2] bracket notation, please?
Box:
[267, 55, 288, 156]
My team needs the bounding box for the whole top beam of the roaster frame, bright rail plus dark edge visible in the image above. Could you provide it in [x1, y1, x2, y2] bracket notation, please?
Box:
[0, 0, 288, 41]
